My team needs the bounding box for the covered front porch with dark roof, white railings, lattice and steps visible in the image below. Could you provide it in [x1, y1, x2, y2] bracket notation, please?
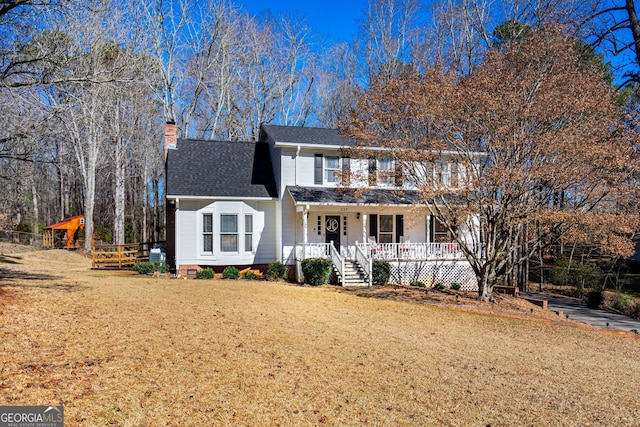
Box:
[284, 187, 477, 290]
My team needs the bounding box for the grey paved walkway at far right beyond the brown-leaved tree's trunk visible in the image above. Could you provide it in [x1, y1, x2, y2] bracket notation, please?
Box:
[520, 293, 640, 333]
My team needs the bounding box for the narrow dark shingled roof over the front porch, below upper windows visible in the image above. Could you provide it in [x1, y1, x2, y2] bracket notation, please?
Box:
[287, 186, 420, 205]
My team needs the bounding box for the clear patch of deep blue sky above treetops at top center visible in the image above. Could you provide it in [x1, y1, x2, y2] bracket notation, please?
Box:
[233, 0, 367, 42]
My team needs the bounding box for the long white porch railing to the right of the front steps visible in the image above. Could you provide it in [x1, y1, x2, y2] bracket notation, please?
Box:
[358, 243, 465, 260]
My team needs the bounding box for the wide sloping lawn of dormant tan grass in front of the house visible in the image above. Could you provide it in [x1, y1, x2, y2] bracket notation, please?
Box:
[0, 251, 640, 426]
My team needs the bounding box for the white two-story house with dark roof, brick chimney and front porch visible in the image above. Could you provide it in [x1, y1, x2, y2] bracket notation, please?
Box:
[165, 125, 477, 290]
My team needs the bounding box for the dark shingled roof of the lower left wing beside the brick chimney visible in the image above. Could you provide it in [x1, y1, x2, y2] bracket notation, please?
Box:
[167, 139, 278, 197]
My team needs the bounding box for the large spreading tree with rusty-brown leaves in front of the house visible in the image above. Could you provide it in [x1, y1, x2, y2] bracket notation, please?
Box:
[348, 27, 638, 300]
